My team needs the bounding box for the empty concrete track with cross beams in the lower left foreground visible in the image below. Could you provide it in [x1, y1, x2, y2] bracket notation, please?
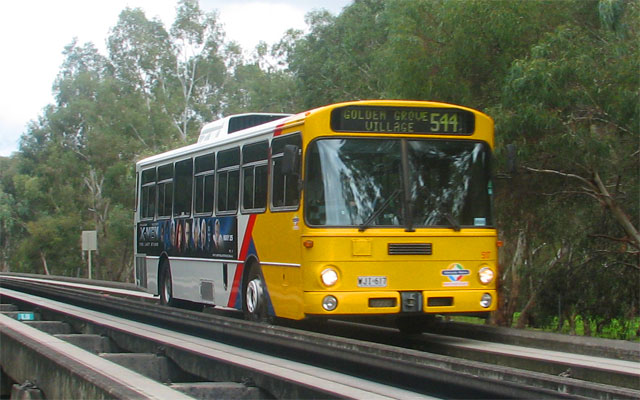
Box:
[0, 285, 428, 399]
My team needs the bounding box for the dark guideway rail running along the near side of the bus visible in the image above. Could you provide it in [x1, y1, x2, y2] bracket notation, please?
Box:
[1, 279, 571, 399]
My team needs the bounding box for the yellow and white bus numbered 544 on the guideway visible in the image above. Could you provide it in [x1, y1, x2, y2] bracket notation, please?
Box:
[135, 100, 498, 323]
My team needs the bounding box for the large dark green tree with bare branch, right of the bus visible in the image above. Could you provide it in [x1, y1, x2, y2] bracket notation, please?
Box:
[493, 1, 640, 330]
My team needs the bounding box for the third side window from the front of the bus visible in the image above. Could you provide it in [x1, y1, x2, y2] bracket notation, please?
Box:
[216, 147, 240, 214]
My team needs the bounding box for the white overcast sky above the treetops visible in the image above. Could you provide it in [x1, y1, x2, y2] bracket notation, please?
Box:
[0, 0, 352, 156]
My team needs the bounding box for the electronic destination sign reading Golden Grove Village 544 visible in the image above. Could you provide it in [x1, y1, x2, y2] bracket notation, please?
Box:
[331, 106, 475, 135]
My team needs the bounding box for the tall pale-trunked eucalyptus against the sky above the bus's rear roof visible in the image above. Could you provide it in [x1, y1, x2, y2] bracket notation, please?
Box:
[108, 0, 226, 147]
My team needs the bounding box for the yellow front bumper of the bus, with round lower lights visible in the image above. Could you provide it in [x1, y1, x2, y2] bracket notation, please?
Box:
[304, 289, 498, 316]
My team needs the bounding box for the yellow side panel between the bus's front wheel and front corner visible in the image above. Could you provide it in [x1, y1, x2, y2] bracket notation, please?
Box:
[253, 210, 304, 319]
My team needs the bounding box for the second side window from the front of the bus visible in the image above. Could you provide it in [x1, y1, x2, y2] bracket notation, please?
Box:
[242, 141, 269, 213]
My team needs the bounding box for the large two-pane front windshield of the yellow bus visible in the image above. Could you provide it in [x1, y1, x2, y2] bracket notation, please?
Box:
[305, 138, 493, 230]
